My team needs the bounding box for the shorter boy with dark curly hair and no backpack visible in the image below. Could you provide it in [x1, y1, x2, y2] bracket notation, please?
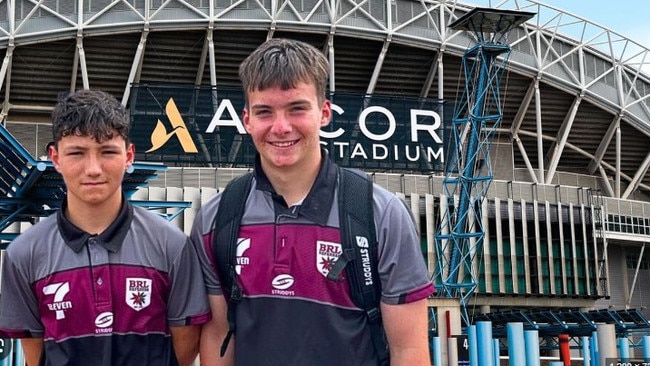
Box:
[0, 90, 210, 366]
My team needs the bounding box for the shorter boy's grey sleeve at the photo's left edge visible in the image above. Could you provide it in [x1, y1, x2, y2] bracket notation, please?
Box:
[0, 246, 43, 338]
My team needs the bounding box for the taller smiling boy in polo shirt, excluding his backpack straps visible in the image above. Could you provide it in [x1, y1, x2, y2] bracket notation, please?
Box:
[191, 39, 434, 366]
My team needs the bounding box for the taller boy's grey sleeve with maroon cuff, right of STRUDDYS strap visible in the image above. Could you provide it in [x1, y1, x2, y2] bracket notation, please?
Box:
[375, 194, 435, 305]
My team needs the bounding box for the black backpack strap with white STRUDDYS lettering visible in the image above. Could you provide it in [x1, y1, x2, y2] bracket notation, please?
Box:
[327, 168, 389, 365]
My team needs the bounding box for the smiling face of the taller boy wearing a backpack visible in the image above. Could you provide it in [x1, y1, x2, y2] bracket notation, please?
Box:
[243, 82, 332, 174]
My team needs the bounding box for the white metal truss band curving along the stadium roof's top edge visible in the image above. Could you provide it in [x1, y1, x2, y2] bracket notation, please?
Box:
[0, 0, 650, 116]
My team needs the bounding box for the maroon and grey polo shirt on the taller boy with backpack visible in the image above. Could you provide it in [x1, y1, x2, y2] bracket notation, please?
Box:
[190, 158, 434, 366]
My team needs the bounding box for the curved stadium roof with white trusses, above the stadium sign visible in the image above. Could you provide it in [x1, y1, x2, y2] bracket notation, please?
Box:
[0, 0, 650, 198]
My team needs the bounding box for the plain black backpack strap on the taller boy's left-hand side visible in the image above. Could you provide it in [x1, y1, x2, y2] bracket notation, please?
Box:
[212, 173, 253, 357]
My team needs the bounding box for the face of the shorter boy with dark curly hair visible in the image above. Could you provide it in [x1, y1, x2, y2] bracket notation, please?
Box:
[50, 133, 135, 208]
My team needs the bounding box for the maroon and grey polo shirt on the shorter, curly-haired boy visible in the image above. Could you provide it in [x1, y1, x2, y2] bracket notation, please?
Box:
[0, 201, 210, 366]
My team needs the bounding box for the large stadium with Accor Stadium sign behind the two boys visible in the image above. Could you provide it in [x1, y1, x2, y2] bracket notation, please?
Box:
[0, 0, 650, 362]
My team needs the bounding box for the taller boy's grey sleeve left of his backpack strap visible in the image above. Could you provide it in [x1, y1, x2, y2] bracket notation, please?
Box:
[190, 195, 223, 295]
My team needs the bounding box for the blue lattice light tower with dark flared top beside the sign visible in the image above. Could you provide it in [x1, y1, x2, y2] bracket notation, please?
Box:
[433, 8, 535, 325]
